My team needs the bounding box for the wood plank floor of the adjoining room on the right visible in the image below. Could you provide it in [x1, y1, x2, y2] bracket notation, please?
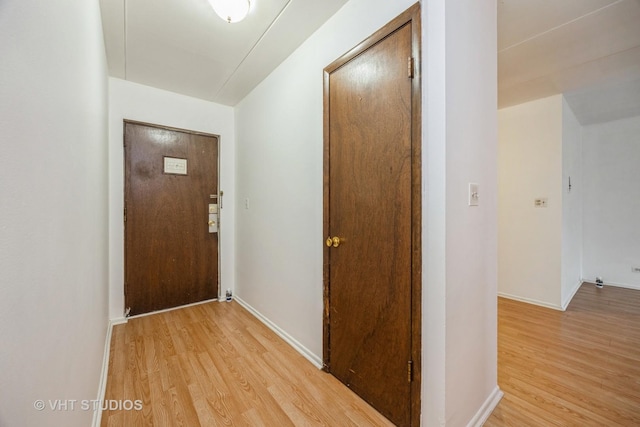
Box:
[485, 283, 640, 427]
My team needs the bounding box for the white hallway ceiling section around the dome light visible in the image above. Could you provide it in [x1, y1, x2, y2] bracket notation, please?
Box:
[100, 0, 347, 105]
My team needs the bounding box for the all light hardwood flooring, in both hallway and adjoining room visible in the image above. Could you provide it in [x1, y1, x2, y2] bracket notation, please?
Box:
[102, 284, 640, 427]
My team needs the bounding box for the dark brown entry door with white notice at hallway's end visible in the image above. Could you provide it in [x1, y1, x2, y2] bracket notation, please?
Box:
[124, 122, 218, 315]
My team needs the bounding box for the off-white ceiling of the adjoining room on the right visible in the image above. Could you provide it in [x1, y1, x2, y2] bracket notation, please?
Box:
[498, 0, 640, 125]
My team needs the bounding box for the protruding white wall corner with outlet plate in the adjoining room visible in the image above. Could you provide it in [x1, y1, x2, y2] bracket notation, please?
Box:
[498, 95, 584, 310]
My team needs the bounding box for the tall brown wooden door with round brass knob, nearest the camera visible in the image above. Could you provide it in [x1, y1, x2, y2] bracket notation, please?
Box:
[325, 5, 420, 426]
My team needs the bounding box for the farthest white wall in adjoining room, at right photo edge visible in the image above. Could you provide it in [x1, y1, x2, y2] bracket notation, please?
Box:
[583, 117, 640, 289]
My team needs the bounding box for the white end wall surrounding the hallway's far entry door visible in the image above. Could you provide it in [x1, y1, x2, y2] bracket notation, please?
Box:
[109, 78, 235, 319]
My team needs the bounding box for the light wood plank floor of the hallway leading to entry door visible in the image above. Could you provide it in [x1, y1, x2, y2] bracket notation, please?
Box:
[101, 301, 392, 427]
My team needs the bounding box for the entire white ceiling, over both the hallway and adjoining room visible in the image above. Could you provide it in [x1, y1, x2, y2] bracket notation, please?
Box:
[100, 0, 640, 124]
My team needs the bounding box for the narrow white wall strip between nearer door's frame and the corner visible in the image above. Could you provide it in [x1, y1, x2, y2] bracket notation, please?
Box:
[421, 1, 448, 426]
